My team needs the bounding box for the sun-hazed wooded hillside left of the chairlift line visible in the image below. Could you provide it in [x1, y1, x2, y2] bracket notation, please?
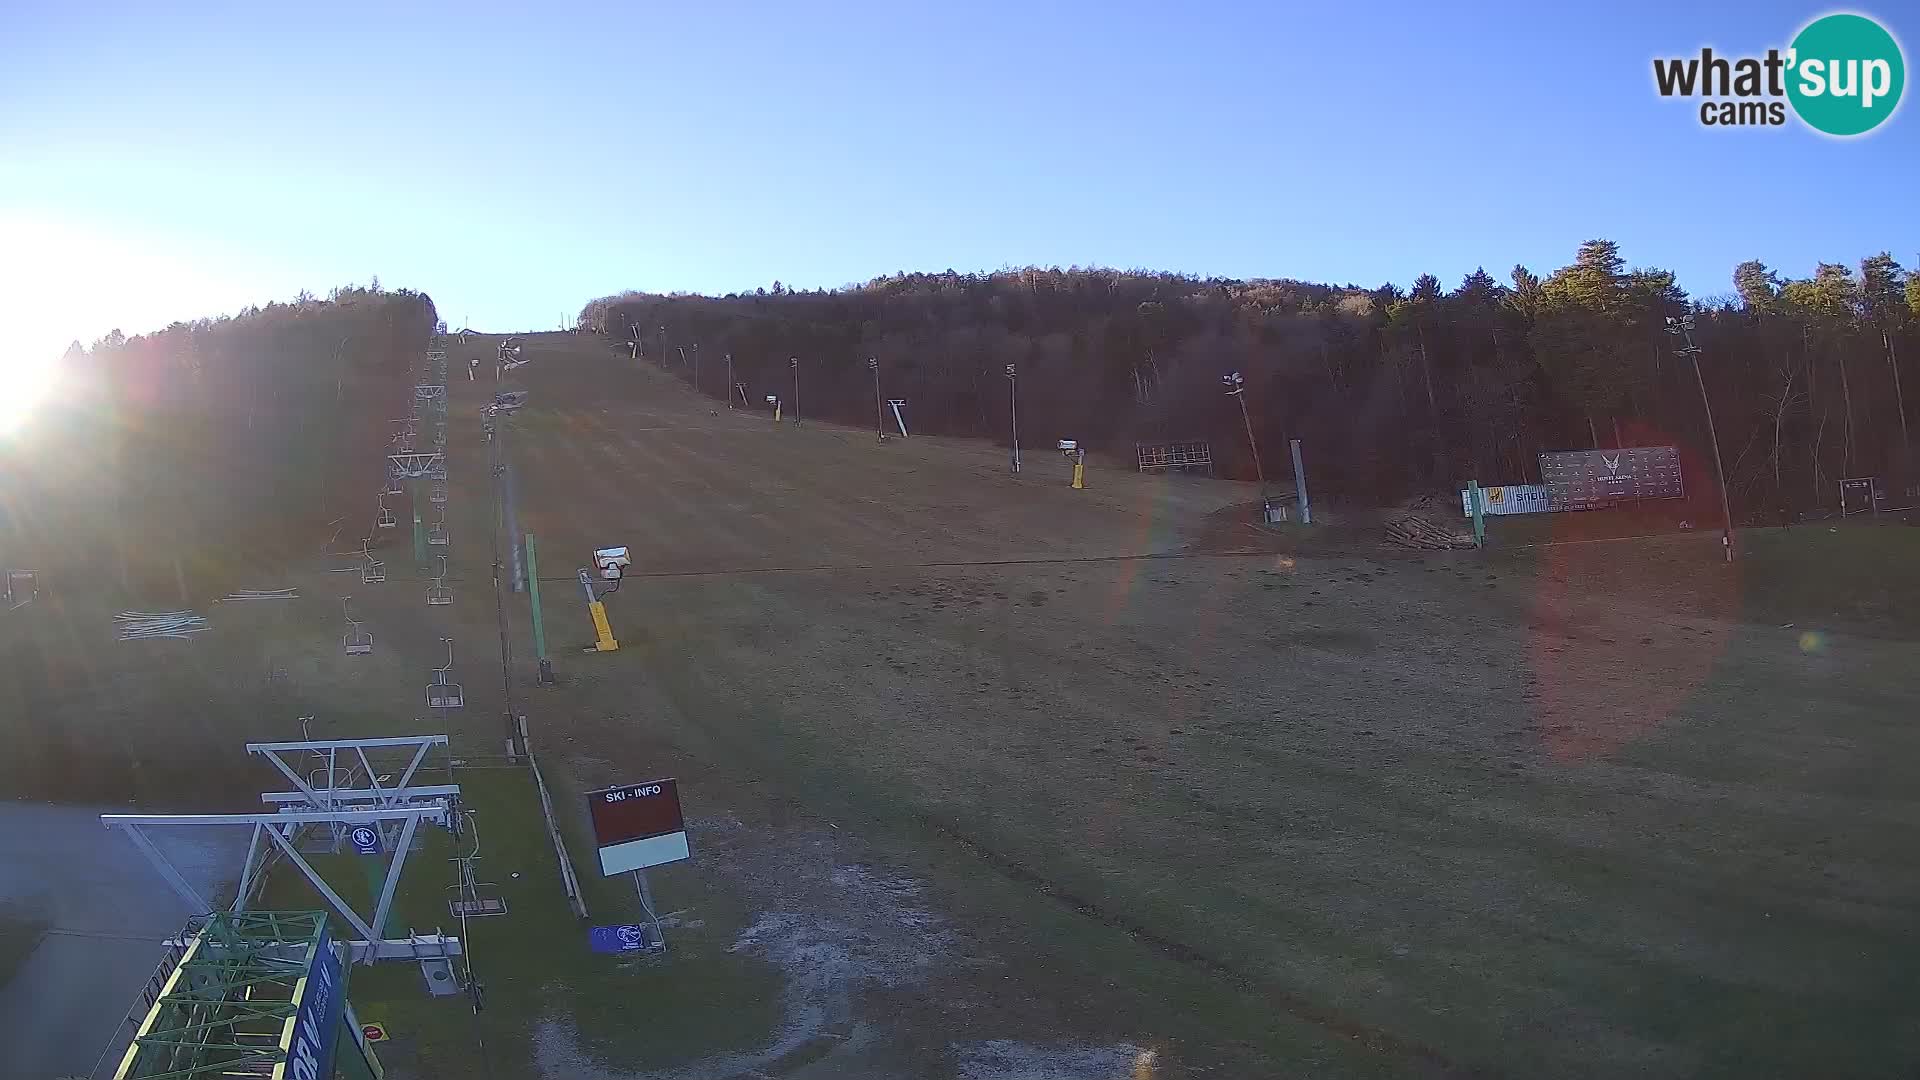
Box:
[0, 281, 436, 584]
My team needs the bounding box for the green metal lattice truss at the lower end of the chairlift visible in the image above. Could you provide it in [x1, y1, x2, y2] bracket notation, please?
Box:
[113, 911, 337, 1080]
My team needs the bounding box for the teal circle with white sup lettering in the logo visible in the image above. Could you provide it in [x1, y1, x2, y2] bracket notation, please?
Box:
[1788, 13, 1907, 136]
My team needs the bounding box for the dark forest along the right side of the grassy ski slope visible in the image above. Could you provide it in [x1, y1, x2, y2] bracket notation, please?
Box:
[580, 240, 1920, 513]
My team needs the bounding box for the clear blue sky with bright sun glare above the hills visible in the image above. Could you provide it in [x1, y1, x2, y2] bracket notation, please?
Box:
[0, 0, 1920, 363]
